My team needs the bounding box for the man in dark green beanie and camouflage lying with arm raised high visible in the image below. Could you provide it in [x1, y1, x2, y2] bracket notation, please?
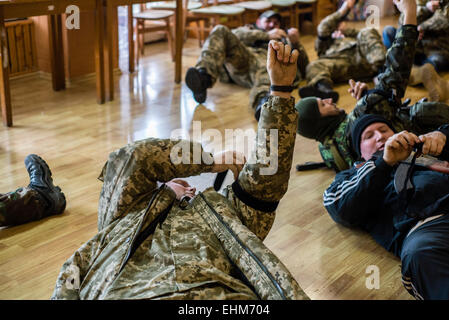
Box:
[296, 1, 449, 172]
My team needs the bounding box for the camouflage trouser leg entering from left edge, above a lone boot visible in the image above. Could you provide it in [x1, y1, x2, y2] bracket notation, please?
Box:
[0, 187, 46, 227]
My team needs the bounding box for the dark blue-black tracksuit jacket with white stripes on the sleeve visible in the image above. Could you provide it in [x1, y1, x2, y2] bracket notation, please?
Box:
[323, 125, 449, 256]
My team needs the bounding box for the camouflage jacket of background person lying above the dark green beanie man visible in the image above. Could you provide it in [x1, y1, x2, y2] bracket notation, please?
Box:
[315, 11, 359, 58]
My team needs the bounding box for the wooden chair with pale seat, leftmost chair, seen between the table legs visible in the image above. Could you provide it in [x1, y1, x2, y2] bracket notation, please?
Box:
[133, 4, 175, 64]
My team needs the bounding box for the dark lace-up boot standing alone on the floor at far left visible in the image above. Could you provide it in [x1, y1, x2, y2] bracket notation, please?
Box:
[25, 154, 66, 215]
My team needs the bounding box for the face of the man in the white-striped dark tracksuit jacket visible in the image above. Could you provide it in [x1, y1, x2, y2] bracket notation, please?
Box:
[360, 122, 394, 160]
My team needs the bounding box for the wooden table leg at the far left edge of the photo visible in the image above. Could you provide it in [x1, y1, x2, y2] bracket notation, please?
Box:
[0, 7, 12, 127]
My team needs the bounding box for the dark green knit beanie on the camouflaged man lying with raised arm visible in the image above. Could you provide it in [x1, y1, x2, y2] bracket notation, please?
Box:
[295, 97, 346, 142]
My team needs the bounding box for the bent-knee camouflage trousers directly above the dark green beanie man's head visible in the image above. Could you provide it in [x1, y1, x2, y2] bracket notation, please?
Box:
[306, 28, 386, 85]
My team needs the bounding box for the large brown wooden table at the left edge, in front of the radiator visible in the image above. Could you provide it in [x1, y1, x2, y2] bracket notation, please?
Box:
[0, 0, 105, 127]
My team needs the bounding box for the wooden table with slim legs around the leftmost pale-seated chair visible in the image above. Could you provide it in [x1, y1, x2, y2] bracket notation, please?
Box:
[104, 0, 184, 101]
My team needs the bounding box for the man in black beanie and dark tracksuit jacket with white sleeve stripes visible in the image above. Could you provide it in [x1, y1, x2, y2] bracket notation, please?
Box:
[323, 104, 449, 300]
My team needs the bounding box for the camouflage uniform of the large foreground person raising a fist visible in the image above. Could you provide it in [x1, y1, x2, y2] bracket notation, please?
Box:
[52, 97, 307, 299]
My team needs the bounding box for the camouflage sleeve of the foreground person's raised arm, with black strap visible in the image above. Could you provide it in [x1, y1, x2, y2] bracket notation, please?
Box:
[221, 96, 298, 240]
